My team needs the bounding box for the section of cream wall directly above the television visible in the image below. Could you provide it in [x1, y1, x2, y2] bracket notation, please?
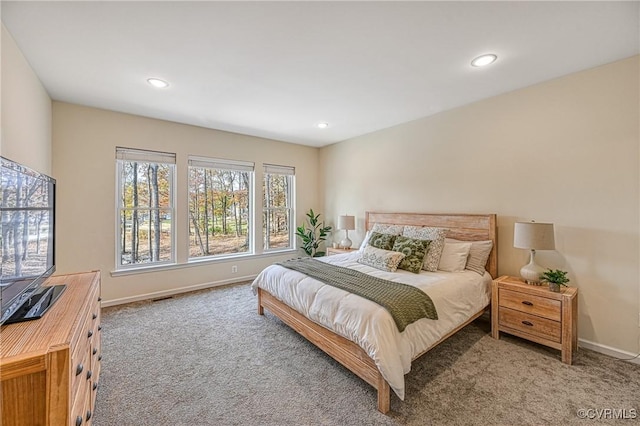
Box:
[0, 24, 51, 174]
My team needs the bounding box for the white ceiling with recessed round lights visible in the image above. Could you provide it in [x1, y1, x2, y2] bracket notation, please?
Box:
[1, 1, 640, 146]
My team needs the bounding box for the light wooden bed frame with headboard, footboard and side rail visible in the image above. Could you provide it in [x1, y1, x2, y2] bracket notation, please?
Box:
[258, 212, 498, 413]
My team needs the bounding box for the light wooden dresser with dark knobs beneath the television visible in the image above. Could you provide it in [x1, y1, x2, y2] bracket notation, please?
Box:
[0, 271, 101, 426]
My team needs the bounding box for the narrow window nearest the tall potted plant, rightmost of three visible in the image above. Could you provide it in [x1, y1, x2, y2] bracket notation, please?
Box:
[262, 164, 295, 251]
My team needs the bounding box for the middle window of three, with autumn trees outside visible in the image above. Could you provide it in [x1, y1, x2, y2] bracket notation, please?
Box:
[188, 157, 254, 260]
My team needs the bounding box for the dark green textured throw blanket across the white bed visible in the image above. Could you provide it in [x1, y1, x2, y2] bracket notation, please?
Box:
[276, 258, 438, 332]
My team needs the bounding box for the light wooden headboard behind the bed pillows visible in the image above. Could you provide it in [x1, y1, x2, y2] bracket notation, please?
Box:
[365, 212, 498, 278]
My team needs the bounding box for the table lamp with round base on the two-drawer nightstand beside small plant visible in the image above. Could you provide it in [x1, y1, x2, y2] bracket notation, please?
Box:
[513, 222, 556, 285]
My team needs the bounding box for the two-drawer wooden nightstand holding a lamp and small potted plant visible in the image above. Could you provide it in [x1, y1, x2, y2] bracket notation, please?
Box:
[491, 275, 578, 364]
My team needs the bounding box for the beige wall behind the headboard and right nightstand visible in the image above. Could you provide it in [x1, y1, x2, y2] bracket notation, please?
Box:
[320, 57, 640, 353]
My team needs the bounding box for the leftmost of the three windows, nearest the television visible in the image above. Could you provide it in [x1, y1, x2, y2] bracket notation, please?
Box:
[116, 147, 176, 269]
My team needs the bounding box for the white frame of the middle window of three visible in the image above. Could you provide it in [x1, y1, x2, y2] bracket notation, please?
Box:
[186, 155, 256, 263]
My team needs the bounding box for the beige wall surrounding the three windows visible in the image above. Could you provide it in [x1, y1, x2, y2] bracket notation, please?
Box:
[53, 102, 319, 303]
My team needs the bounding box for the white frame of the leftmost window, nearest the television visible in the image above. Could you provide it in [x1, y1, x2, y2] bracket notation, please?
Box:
[115, 147, 176, 271]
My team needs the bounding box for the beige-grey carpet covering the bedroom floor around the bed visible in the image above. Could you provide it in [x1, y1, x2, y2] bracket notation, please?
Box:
[93, 283, 640, 426]
